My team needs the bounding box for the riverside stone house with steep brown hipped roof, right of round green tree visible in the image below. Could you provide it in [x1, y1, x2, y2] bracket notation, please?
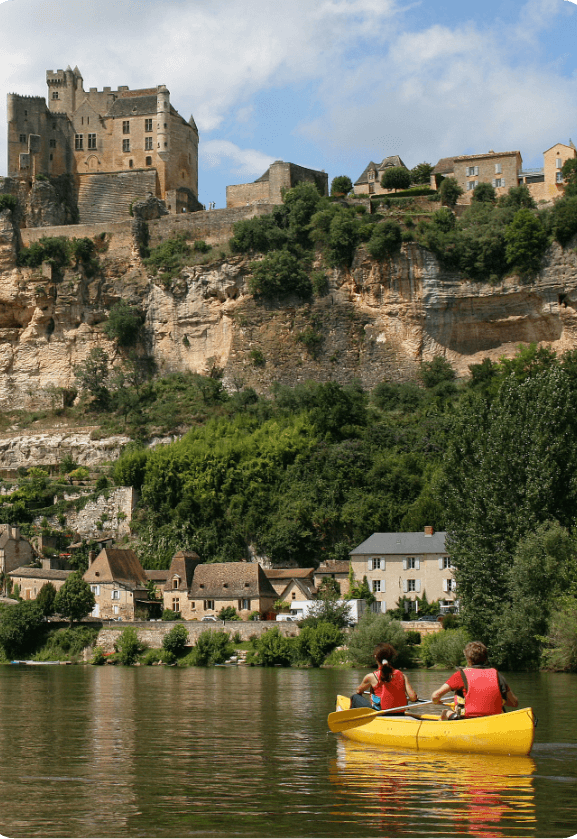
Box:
[84, 548, 154, 620]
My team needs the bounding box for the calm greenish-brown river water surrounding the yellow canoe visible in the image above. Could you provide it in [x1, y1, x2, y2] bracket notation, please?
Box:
[0, 666, 577, 839]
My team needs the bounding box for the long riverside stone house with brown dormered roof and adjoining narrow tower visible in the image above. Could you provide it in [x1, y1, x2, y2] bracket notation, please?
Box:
[164, 558, 277, 620]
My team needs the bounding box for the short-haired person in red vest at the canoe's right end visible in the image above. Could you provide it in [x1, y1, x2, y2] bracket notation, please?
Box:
[431, 641, 519, 720]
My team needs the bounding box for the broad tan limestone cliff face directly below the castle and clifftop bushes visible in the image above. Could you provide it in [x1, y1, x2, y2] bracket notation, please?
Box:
[0, 211, 577, 408]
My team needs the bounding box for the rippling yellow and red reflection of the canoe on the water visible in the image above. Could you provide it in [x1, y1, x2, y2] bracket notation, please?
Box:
[330, 739, 536, 839]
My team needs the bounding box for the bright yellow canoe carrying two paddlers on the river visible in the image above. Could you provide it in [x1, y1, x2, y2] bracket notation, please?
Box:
[337, 696, 535, 755]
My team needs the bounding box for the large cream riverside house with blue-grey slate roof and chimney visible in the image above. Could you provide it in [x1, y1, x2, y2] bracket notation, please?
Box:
[350, 527, 457, 612]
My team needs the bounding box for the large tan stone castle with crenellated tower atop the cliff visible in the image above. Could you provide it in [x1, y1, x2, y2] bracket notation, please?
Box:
[8, 67, 200, 224]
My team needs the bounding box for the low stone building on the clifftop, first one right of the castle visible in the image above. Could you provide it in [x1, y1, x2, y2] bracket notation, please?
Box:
[226, 160, 329, 209]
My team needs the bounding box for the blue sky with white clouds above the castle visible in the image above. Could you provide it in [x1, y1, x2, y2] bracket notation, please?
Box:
[0, 0, 577, 207]
